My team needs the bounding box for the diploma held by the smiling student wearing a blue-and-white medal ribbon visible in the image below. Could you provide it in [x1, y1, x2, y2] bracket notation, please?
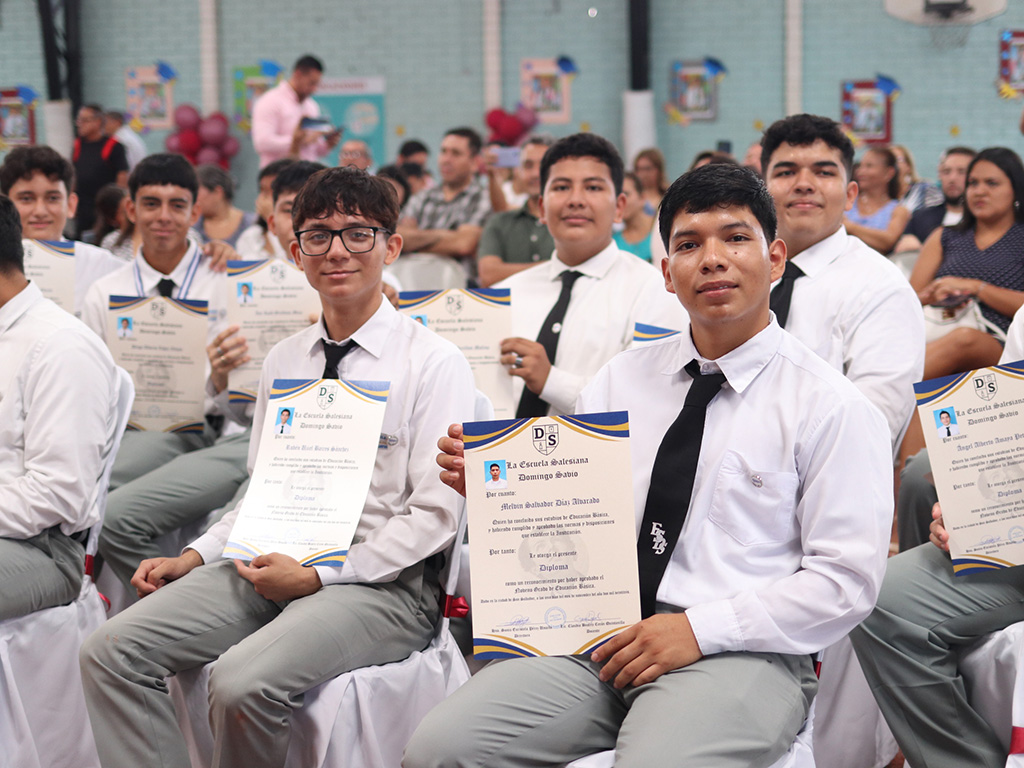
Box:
[106, 296, 209, 432]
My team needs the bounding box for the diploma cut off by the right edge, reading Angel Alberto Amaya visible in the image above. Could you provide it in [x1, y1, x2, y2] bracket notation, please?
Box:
[913, 360, 1024, 575]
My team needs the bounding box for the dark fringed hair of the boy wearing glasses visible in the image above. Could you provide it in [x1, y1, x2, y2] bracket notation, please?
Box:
[290, 166, 398, 232]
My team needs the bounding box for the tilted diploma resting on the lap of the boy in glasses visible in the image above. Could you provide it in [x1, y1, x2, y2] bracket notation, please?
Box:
[224, 379, 390, 566]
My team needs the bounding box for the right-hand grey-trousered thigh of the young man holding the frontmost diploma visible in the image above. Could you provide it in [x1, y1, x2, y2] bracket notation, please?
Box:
[615, 653, 817, 768]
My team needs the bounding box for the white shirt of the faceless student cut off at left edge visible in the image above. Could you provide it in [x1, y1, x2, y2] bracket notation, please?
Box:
[0, 283, 118, 539]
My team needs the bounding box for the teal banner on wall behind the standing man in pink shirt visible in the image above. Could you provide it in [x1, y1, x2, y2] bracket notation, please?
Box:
[313, 77, 387, 166]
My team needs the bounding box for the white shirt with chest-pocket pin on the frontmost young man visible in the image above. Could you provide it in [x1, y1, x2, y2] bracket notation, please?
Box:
[577, 319, 893, 655]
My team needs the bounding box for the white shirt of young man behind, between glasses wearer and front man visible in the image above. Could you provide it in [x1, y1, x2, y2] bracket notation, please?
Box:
[495, 243, 686, 415]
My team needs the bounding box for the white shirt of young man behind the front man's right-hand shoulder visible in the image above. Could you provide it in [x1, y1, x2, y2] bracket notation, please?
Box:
[785, 227, 925, 455]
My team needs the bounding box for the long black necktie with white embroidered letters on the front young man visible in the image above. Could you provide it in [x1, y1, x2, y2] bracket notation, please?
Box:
[637, 360, 725, 618]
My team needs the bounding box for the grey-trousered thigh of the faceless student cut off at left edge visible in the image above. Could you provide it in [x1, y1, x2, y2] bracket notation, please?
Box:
[0, 528, 85, 621]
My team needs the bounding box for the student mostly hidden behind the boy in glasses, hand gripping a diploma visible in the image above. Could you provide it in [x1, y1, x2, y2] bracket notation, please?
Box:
[99, 160, 326, 594]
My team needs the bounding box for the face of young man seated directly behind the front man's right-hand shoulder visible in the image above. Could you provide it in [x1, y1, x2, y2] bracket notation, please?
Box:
[765, 139, 857, 256]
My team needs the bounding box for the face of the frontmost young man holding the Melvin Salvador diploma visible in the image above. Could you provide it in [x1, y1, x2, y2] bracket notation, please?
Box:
[662, 201, 785, 356]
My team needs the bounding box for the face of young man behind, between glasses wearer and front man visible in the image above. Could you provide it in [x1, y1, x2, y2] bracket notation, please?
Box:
[541, 158, 626, 263]
